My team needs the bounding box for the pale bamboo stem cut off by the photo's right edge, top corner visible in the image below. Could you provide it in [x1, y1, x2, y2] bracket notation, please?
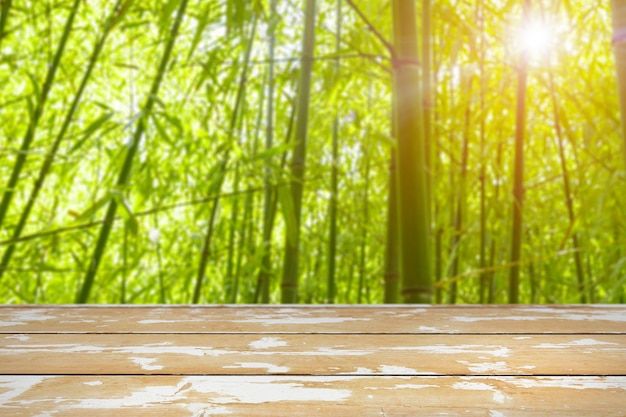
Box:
[611, 0, 626, 170]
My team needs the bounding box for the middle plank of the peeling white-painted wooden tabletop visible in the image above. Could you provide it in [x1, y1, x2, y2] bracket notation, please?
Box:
[0, 334, 626, 375]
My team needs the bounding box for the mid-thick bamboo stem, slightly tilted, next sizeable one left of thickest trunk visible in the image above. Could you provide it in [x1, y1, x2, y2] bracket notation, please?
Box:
[281, 0, 315, 303]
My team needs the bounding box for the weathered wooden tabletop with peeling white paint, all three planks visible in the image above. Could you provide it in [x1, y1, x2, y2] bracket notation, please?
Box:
[0, 306, 626, 417]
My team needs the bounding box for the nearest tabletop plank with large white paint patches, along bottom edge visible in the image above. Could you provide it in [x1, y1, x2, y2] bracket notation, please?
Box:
[0, 376, 626, 417]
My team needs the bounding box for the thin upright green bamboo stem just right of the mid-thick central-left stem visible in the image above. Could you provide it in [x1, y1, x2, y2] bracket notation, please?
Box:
[326, 0, 342, 304]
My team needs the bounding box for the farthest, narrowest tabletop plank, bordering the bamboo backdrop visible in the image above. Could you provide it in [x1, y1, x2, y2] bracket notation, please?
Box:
[0, 305, 626, 334]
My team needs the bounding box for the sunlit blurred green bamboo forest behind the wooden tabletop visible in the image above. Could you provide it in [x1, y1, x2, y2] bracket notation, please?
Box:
[0, 0, 626, 304]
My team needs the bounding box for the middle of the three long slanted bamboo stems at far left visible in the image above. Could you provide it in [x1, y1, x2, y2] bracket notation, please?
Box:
[0, 0, 128, 280]
